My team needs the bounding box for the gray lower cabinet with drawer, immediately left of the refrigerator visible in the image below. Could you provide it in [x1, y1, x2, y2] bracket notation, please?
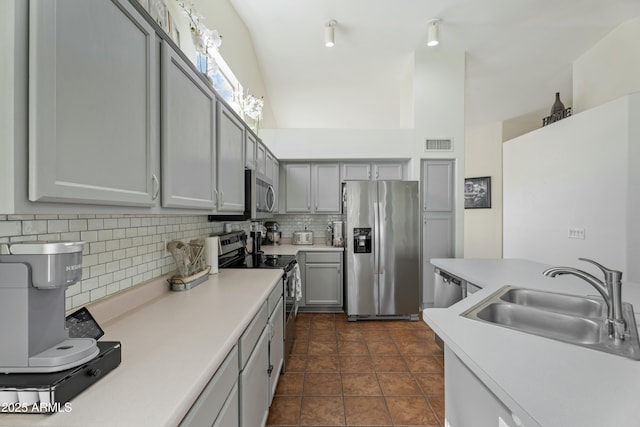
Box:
[303, 252, 344, 308]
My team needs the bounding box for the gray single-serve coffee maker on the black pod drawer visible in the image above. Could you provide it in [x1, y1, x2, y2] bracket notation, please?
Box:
[0, 241, 99, 373]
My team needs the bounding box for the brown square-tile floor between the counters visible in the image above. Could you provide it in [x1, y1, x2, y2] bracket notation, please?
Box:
[267, 313, 444, 427]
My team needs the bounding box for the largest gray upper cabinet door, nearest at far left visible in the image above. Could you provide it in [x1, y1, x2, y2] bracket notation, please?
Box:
[29, 0, 159, 206]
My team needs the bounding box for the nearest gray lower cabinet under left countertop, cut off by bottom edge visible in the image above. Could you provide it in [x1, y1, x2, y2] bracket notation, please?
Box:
[180, 346, 239, 427]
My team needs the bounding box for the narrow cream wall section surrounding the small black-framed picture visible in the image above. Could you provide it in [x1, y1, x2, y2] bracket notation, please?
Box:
[464, 122, 502, 258]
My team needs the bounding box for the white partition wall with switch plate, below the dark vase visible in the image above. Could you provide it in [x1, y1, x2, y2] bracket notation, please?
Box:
[503, 95, 640, 280]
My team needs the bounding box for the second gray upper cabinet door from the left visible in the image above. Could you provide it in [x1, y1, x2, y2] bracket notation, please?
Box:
[161, 42, 216, 211]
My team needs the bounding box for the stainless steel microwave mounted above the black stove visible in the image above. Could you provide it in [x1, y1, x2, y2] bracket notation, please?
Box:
[208, 169, 277, 221]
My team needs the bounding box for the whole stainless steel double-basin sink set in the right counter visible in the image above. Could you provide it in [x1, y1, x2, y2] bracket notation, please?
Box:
[461, 286, 640, 360]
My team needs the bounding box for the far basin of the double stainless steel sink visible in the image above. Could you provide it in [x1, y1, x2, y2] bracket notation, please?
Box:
[500, 288, 607, 317]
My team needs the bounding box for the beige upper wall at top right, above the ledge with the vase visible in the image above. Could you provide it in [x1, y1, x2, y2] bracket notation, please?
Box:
[573, 17, 640, 113]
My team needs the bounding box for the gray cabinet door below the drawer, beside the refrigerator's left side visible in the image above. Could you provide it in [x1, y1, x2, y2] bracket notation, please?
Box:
[304, 263, 342, 306]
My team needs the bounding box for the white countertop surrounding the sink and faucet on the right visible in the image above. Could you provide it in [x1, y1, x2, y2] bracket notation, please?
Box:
[424, 259, 640, 427]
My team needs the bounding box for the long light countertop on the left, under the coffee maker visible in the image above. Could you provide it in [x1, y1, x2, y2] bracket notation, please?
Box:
[0, 269, 282, 426]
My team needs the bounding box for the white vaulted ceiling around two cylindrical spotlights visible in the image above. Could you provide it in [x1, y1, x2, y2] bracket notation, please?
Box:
[225, 0, 640, 128]
